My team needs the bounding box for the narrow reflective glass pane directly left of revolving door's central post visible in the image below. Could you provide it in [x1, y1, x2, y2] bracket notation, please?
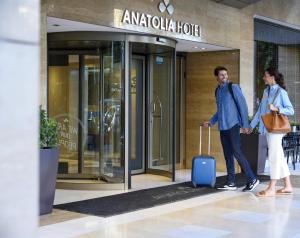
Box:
[101, 42, 124, 182]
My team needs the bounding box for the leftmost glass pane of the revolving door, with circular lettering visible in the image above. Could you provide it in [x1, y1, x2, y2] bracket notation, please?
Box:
[48, 55, 79, 173]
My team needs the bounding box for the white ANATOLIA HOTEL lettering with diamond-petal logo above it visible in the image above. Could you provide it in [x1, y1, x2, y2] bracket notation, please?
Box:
[116, 0, 202, 41]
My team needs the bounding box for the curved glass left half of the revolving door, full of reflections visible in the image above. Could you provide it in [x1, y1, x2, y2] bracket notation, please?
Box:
[48, 42, 124, 183]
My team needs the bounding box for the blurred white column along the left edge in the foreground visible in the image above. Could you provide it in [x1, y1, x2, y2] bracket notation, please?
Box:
[0, 0, 40, 238]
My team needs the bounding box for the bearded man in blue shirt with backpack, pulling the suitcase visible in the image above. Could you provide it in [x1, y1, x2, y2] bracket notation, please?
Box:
[204, 66, 259, 192]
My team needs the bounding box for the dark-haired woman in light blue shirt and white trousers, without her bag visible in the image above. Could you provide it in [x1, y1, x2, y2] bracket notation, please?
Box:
[250, 68, 294, 197]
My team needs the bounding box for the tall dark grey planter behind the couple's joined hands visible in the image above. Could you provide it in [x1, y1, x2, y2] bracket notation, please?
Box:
[241, 117, 268, 174]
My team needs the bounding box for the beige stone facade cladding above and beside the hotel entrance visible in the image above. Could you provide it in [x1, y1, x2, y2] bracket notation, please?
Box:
[41, 0, 300, 113]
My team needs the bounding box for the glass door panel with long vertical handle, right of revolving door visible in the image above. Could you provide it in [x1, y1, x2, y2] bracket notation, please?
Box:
[148, 52, 173, 173]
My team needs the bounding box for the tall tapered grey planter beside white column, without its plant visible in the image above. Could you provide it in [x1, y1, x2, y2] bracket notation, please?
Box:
[39, 148, 59, 215]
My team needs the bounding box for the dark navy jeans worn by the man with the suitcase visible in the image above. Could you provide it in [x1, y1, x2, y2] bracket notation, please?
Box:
[220, 124, 256, 183]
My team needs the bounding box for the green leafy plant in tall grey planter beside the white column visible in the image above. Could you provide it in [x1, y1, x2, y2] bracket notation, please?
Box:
[39, 107, 59, 215]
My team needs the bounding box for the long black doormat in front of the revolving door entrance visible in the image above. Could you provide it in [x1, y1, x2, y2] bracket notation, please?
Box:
[54, 174, 269, 217]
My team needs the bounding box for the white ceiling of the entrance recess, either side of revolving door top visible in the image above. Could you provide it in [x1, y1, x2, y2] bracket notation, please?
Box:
[47, 17, 232, 52]
